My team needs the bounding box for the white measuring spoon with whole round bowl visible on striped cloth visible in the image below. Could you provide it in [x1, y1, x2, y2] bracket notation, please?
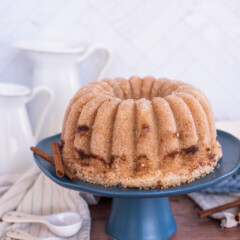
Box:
[2, 211, 83, 237]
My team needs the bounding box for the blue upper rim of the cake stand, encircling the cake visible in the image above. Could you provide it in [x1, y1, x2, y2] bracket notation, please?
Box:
[33, 130, 240, 198]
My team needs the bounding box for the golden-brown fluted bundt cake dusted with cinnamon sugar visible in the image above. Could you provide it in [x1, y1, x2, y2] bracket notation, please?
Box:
[61, 76, 222, 188]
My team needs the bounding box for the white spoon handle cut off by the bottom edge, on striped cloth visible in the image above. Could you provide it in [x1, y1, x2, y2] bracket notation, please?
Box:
[5, 229, 59, 240]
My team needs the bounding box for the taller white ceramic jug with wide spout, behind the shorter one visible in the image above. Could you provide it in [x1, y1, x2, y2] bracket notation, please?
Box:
[14, 41, 110, 138]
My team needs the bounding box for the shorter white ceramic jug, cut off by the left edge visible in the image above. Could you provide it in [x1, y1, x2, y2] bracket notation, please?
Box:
[0, 83, 53, 175]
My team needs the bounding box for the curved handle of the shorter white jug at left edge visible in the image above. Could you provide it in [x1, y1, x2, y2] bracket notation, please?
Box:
[26, 86, 53, 140]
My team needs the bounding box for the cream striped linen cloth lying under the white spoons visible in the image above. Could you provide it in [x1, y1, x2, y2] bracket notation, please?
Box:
[0, 165, 98, 240]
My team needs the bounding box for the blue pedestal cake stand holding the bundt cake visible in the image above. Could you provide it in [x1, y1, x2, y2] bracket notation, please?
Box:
[34, 131, 240, 240]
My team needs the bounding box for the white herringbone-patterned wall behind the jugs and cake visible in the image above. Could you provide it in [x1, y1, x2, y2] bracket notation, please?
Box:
[0, 0, 240, 120]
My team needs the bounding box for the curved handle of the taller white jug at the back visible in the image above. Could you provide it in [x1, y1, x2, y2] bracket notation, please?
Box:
[77, 44, 111, 81]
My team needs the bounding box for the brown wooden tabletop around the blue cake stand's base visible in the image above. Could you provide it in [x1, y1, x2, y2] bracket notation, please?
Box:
[90, 195, 240, 240]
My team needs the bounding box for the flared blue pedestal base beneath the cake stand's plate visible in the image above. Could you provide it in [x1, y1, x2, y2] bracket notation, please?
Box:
[106, 197, 177, 240]
